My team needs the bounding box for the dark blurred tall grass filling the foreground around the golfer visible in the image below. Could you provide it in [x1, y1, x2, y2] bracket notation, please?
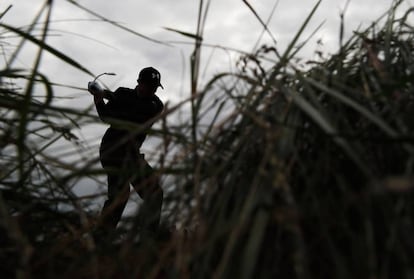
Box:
[0, 1, 414, 278]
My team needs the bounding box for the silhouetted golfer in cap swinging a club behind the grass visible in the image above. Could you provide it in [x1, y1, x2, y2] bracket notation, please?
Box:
[88, 67, 164, 235]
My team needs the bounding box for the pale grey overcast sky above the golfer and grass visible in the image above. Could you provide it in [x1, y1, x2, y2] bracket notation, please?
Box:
[0, 0, 413, 103]
